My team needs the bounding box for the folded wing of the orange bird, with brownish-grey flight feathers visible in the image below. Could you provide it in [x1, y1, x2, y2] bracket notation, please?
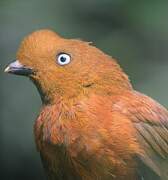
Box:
[114, 91, 168, 180]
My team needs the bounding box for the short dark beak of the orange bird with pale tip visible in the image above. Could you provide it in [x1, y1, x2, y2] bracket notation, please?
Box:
[4, 60, 33, 76]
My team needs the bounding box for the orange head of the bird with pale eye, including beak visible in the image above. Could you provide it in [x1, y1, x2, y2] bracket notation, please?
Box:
[5, 30, 131, 103]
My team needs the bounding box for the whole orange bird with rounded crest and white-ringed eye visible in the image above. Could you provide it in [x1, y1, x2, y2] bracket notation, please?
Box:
[5, 30, 168, 180]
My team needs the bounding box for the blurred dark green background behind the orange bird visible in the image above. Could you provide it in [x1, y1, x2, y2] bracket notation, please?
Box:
[0, 0, 168, 180]
